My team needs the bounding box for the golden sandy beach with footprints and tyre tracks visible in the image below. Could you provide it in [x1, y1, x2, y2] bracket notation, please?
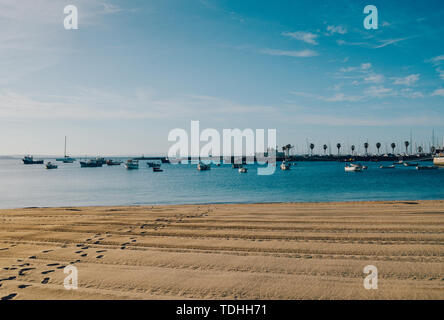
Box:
[0, 201, 444, 299]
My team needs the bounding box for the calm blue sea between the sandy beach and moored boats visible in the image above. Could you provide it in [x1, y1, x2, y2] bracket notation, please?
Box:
[0, 159, 444, 208]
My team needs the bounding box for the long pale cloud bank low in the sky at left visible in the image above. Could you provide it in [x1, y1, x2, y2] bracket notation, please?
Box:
[0, 89, 277, 119]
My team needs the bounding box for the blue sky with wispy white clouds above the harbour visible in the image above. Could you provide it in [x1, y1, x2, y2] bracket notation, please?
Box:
[0, 0, 444, 155]
